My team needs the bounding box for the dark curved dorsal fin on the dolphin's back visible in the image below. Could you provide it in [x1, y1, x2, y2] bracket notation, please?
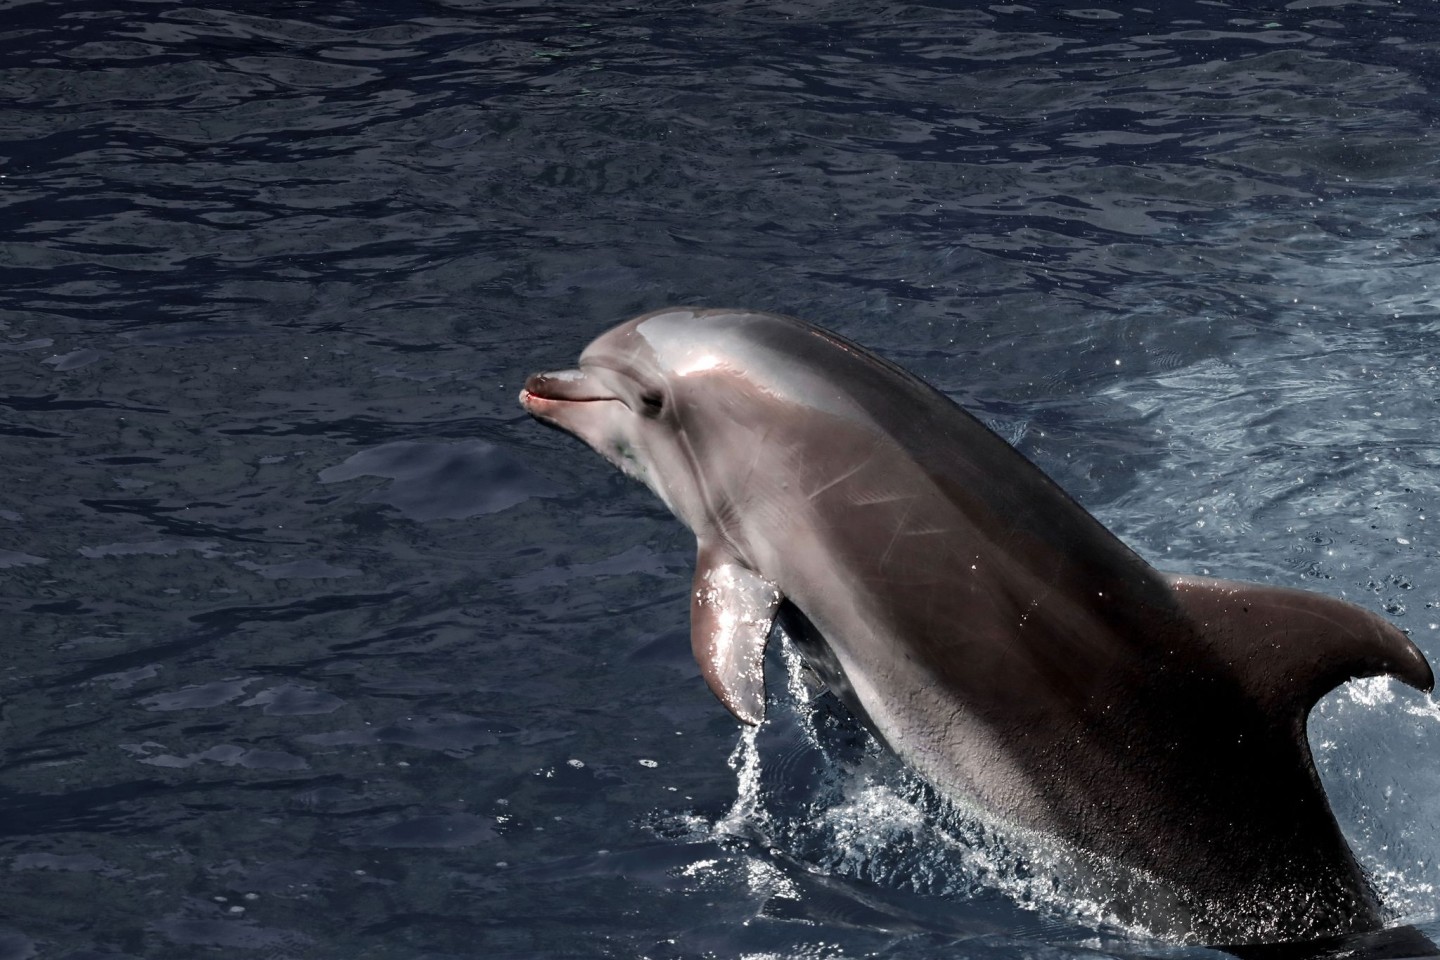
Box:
[1169, 576, 1434, 723]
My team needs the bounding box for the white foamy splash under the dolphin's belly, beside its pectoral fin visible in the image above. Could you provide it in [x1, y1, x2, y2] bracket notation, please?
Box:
[711, 632, 1153, 936]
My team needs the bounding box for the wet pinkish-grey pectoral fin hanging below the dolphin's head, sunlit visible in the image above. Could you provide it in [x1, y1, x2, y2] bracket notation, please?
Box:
[690, 541, 782, 725]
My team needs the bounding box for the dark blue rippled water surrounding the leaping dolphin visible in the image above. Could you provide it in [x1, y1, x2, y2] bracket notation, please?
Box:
[0, 0, 1440, 960]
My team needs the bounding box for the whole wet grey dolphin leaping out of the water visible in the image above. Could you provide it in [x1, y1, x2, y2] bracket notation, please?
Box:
[520, 308, 1434, 944]
